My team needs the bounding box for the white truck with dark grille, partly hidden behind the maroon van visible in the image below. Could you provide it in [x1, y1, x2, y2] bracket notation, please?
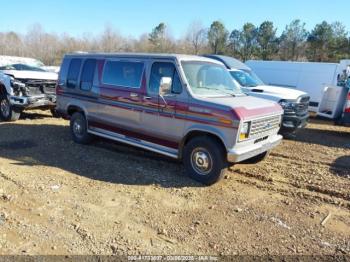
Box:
[205, 55, 310, 136]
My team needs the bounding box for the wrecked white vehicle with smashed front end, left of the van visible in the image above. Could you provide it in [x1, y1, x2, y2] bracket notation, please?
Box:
[0, 61, 58, 121]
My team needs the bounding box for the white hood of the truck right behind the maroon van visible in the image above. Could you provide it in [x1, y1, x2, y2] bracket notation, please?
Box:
[242, 85, 307, 102]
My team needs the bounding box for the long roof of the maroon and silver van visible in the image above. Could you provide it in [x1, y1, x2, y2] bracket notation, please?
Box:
[65, 52, 222, 64]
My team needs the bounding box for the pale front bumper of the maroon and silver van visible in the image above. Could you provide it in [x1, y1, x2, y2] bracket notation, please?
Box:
[227, 135, 282, 163]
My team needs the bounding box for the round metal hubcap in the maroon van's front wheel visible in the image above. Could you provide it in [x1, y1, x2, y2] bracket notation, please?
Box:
[191, 148, 213, 175]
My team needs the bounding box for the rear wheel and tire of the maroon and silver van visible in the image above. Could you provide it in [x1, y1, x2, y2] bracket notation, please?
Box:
[70, 112, 92, 145]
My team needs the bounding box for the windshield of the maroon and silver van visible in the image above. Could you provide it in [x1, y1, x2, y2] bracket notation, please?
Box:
[182, 61, 243, 96]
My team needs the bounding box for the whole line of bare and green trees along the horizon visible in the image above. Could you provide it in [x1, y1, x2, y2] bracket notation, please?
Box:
[0, 19, 350, 65]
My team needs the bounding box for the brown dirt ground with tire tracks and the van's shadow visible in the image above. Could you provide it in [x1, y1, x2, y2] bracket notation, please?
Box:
[0, 112, 350, 255]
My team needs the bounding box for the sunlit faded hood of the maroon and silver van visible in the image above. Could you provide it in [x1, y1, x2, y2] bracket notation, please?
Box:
[197, 95, 283, 120]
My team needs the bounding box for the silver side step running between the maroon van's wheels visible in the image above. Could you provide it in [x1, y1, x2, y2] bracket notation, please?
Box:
[88, 127, 179, 159]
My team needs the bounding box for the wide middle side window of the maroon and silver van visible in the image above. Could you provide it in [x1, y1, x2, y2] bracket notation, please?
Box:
[102, 61, 144, 88]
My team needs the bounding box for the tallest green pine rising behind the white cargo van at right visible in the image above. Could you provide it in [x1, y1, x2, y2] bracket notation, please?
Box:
[279, 19, 308, 61]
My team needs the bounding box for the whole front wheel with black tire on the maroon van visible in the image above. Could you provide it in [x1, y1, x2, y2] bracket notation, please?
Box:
[183, 136, 228, 185]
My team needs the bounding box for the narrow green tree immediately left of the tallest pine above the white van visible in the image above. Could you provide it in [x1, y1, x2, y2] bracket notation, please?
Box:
[257, 21, 278, 60]
